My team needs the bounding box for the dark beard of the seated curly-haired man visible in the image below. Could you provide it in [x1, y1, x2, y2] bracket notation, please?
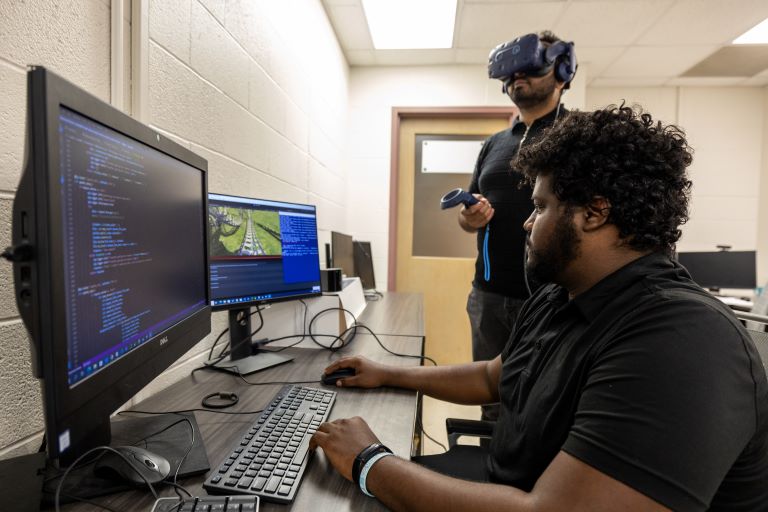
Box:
[525, 208, 580, 291]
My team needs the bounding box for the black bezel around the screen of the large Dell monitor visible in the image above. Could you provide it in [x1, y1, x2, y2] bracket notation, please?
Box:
[13, 66, 211, 461]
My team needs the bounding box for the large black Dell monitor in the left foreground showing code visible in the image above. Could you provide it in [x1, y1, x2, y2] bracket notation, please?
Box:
[11, 67, 211, 472]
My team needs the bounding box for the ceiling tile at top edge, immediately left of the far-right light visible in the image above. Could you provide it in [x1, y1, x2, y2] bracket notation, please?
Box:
[637, 0, 768, 46]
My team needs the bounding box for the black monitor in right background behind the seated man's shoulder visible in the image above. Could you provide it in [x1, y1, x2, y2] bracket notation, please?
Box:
[677, 251, 757, 290]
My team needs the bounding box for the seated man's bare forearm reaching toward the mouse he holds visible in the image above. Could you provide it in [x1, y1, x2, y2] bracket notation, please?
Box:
[384, 361, 499, 405]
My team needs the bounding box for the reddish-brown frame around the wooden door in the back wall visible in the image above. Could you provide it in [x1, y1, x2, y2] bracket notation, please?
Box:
[387, 106, 518, 291]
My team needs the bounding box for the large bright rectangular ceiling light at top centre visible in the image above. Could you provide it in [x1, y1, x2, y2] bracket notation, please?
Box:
[362, 0, 456, 50]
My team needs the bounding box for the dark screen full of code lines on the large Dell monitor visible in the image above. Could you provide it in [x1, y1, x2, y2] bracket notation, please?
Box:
[59, 108, 205, 385]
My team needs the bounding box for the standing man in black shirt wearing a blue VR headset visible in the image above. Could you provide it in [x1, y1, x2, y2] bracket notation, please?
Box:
[459, 31, 576, 420]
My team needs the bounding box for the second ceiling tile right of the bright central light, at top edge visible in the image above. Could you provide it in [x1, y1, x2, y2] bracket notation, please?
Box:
[554, 0, 672, 46]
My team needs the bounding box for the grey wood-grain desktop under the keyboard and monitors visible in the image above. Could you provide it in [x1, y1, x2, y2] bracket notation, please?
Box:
[62, 293, 424, 512]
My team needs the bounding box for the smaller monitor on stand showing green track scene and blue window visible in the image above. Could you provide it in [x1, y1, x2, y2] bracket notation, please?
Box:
[208, 194, 322, 375]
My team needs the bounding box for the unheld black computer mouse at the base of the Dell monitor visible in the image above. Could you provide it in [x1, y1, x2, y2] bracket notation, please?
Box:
[93, 446, 171, 485]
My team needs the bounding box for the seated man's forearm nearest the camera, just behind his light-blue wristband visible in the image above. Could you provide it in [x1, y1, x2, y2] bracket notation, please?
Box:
[366, 457, 532, 512]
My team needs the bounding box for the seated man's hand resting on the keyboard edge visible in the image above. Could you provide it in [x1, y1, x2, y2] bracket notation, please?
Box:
[309, 416, 380, 481]
